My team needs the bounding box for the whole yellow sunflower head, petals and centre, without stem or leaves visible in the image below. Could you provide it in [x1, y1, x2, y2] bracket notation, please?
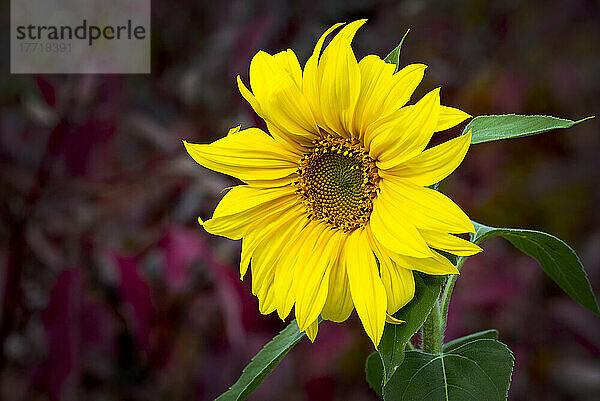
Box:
[184, 20, 481, 347]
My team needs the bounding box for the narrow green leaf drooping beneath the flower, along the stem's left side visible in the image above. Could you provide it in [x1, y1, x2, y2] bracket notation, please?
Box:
[378, 271, 446, 385]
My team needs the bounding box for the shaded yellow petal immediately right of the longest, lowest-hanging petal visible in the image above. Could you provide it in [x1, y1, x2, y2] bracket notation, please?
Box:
[367, 228, 415, 315]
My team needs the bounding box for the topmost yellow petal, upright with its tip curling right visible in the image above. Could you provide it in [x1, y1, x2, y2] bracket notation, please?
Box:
[318, 20, 365, 137]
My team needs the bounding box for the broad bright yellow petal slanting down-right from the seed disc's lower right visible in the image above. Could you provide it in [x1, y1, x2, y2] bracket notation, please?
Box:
[369, 186, 431, 257]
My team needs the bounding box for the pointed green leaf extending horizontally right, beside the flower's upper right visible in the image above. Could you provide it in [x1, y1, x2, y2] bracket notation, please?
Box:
[463, 114, 594, 144]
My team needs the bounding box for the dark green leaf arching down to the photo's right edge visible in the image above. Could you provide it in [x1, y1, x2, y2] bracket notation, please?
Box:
[472, 222, 600, 315]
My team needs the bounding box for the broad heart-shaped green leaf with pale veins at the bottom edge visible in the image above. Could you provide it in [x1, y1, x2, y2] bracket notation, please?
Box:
[383, 339, 514, 401]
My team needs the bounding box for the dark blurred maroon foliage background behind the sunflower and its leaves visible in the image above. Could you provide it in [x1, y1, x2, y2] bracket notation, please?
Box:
[0, 0, 600, 401]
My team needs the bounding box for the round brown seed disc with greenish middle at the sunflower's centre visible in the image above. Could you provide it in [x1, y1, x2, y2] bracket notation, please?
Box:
[296, 136, 379, 231]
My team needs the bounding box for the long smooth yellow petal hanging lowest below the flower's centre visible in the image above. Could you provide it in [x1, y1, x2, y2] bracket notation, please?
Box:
[344, 229, 387, 348]
